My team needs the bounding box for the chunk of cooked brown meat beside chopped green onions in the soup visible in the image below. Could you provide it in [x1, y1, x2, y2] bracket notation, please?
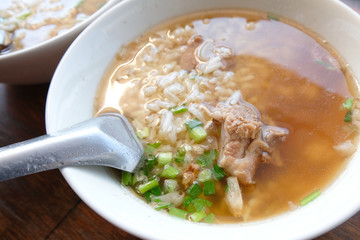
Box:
[209, 91, 288, 185]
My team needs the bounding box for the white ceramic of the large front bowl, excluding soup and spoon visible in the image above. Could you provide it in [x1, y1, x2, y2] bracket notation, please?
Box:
[46, 0, 360, 240]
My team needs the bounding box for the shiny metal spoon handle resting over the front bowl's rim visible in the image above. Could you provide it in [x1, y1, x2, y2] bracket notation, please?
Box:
[0, 113, 143, 181]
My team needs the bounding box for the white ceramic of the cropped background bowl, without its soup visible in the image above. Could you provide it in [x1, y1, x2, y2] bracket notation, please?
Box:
[0, 0, 120, 84]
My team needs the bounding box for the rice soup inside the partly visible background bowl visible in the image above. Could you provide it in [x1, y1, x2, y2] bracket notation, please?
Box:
[0, 0, 107, 54]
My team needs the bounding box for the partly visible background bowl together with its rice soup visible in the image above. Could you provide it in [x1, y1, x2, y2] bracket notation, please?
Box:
[0, 0, 119, 84]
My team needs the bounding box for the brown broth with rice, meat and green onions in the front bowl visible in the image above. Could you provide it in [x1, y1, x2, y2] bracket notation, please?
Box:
[95, 10, 359, 222]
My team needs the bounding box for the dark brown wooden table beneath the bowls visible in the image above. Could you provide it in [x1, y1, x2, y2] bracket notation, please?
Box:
[0, 0, 360, 240]
